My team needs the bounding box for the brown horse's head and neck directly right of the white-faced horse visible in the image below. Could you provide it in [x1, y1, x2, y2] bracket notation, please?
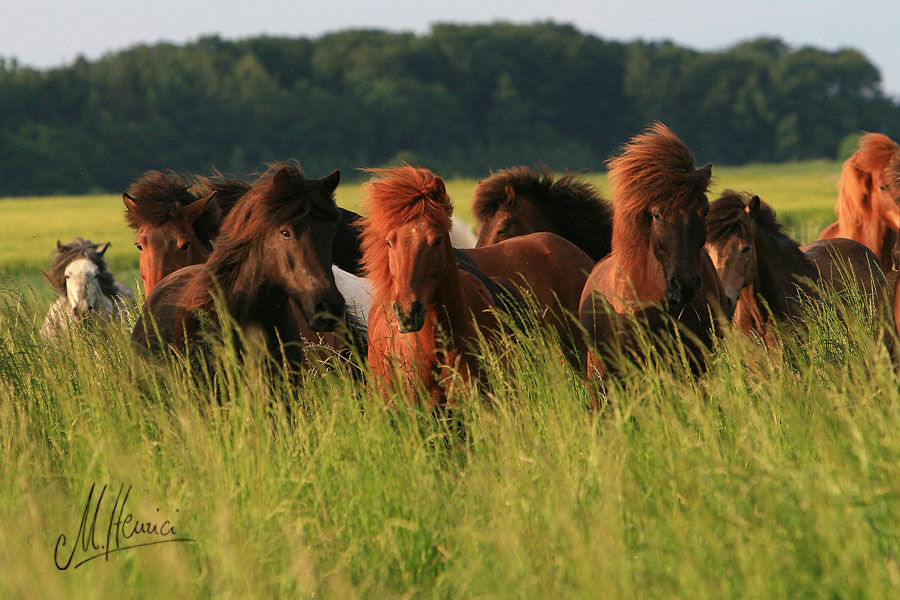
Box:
[122, 171, 222, 297]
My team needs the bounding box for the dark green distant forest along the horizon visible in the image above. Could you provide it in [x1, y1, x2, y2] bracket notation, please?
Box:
[0, 23, 900, 195]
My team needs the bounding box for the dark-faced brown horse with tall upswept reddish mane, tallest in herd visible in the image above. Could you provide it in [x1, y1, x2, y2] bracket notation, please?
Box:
[580, 123, 724, 377]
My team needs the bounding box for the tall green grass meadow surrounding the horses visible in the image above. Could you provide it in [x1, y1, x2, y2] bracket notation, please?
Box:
[0, 162, 900, 598]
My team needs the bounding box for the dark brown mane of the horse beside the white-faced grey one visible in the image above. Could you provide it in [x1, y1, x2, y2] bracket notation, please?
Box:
[125, 171, 222, 248]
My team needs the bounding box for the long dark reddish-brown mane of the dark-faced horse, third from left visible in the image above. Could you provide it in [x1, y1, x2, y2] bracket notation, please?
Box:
[194, 162, 338, 312]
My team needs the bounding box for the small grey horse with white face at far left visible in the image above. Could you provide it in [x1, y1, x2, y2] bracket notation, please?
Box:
[41, 238, 134, 338]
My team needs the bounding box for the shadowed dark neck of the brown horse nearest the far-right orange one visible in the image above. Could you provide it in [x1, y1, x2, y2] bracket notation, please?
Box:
[753, 223, 816, 317]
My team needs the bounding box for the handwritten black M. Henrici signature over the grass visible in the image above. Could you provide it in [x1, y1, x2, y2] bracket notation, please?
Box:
[53, 484, 194, 571]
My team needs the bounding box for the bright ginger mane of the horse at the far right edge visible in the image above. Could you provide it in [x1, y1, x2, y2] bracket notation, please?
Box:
[835, 133, 900, 230]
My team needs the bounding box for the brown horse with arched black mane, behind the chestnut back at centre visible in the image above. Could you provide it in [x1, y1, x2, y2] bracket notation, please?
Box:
[472, 167, 612, 262]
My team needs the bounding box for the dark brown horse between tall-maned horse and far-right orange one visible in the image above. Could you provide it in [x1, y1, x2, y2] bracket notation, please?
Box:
[706, 190, 887, 345]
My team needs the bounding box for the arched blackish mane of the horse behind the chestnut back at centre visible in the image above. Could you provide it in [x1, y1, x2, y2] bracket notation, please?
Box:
[472, 166, 612, 261]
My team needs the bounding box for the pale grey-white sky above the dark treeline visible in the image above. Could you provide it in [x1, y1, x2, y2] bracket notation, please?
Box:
[0, 0, 900, 98]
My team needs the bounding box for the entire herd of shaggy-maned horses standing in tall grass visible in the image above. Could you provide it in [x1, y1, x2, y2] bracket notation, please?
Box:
[42, 123, 900, 406]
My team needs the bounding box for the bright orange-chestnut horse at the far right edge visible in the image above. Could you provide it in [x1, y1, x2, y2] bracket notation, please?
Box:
[819, 133, 900, 271]
